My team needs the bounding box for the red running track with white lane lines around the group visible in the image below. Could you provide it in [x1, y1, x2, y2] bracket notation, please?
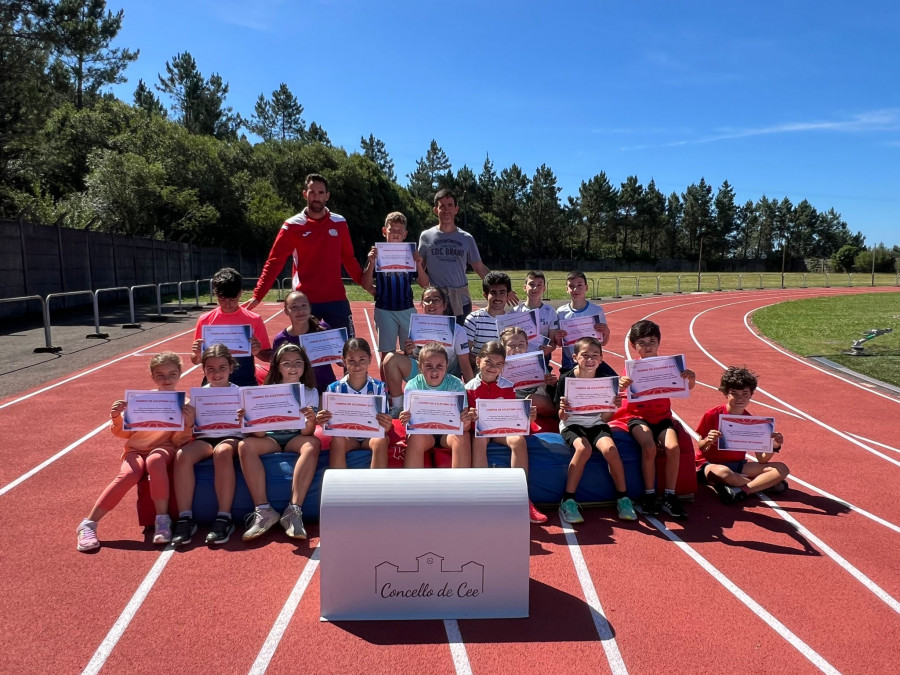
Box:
[0, 289, 900, 673]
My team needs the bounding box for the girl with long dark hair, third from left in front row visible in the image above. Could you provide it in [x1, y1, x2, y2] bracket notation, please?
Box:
[238, 342, 322, 541]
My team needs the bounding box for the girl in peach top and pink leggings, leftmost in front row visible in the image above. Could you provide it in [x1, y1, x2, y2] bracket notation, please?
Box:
[77, 352, 194, 551]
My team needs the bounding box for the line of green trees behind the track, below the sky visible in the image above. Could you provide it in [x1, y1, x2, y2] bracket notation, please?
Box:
[0, 0, 896, 269]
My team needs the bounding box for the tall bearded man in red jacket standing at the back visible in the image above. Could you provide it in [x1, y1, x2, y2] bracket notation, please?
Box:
[247, 173, 362, 337]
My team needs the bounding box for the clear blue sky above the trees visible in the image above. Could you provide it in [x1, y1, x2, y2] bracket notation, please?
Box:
[108, 0, 900, 245]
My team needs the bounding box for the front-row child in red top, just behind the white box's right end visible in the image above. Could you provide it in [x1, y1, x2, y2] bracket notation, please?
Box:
[466, 340, 547, 524]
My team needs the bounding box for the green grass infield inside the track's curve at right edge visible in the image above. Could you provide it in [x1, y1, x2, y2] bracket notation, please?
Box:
[753, 293, 900, 387]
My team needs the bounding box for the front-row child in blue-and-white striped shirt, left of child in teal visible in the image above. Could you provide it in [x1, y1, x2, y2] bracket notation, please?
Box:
[316, 338, 391, 469]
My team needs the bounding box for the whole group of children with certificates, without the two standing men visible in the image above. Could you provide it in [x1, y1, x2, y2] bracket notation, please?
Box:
[77, 213, 788, 551]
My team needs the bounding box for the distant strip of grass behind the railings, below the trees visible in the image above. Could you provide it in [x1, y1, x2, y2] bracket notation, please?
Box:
[255, 270, 900, 301]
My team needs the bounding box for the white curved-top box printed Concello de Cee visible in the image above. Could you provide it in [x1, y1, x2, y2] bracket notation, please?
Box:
[319, 469, 531, 621]
